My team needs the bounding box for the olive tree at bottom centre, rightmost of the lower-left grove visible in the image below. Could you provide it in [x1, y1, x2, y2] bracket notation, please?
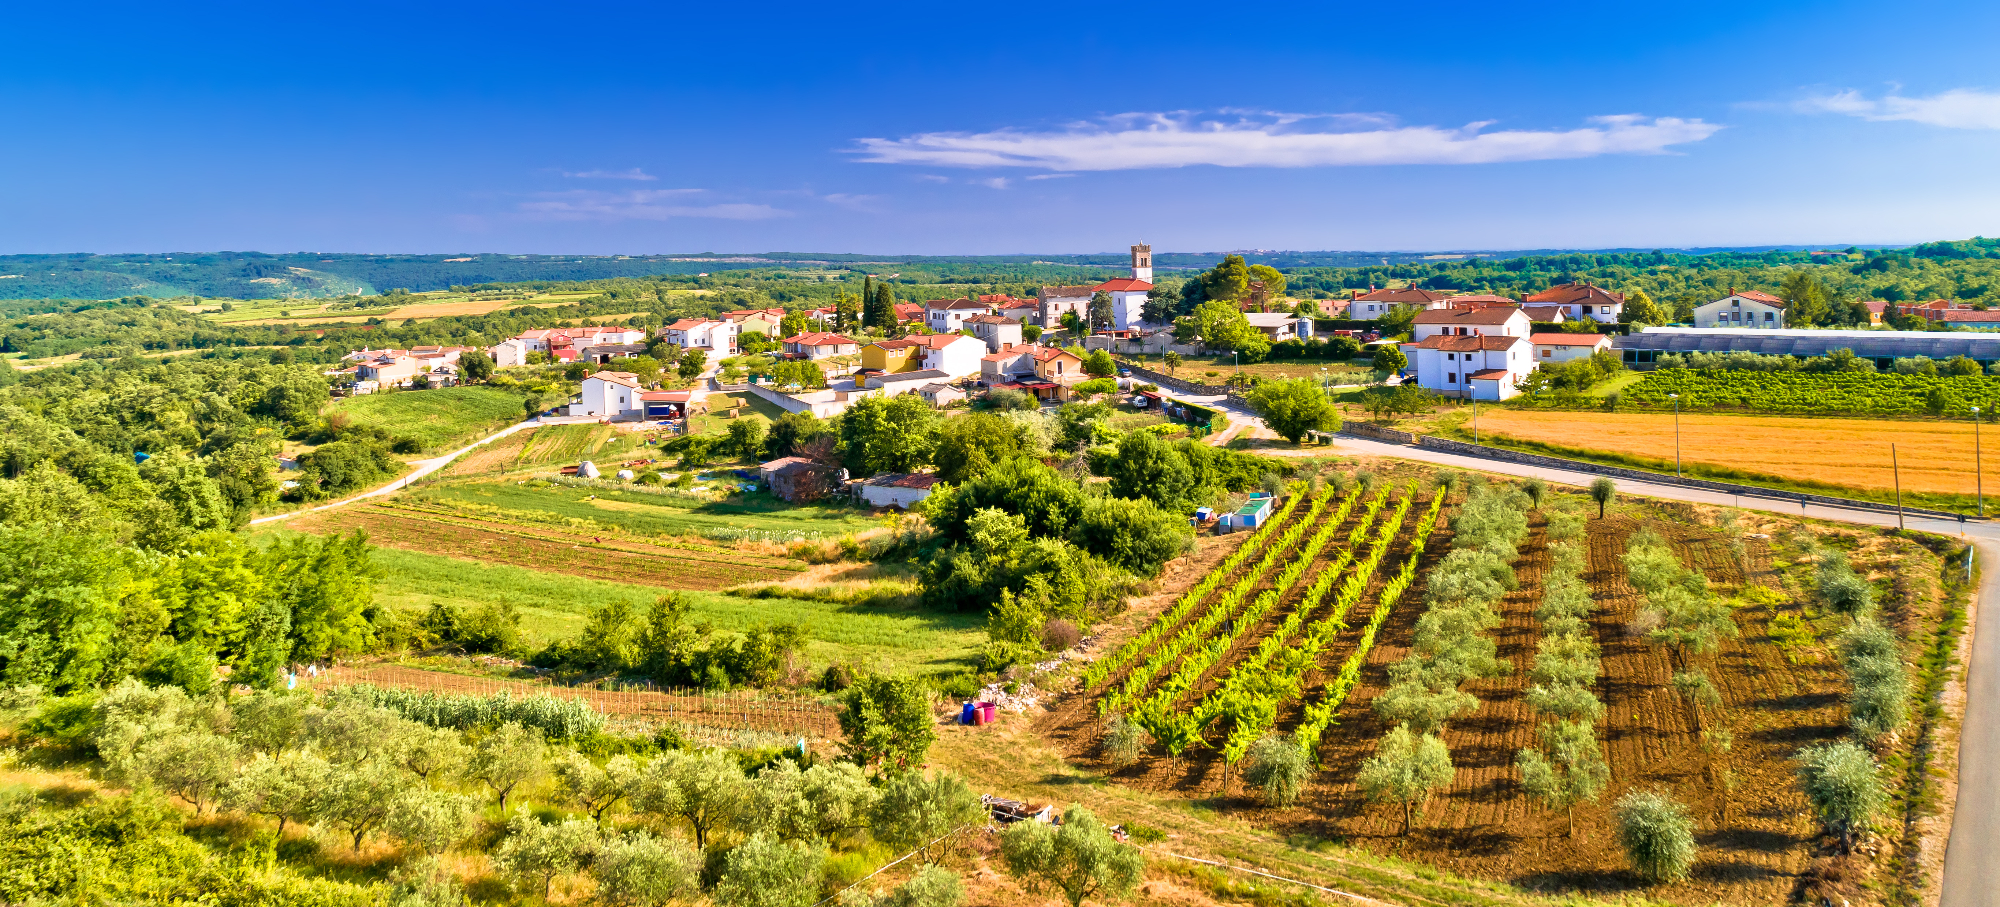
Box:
[1000, 805, 1146, 907]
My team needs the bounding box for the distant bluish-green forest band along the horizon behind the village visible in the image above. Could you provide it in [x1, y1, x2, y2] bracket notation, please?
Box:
[0, 238, 1968, 301]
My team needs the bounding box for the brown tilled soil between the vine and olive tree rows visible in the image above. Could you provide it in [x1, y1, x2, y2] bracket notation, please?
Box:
[1038, 493, 1896, 903]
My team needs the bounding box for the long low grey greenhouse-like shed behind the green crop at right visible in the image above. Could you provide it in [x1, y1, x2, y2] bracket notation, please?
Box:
[1612, 328, 2000, 368]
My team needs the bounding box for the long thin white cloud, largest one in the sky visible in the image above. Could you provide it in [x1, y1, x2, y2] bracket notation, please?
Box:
[850, 110, 1722, 170]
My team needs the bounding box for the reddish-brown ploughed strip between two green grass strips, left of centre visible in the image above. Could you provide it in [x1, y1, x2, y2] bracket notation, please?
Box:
[292, 503, 798, 591]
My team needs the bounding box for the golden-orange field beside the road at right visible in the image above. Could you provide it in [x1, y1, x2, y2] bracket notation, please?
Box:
[1480, 408, 1976, 495]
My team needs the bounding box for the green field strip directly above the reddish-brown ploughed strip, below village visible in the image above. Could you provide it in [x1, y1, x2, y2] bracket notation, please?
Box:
[422, 481, 880, 535]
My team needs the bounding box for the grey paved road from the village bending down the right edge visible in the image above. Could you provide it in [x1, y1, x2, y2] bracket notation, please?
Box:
[1152, 381, 2000, 907]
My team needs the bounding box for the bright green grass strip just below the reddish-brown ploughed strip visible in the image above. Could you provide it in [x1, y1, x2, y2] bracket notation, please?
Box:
[342, 547, 986, 673]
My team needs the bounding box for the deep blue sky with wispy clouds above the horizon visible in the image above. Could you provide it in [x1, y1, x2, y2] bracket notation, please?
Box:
[0, 2, 2000, 254]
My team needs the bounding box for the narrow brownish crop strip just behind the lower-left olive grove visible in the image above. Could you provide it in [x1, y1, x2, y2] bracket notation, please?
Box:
[314, 663, 840, 741]
